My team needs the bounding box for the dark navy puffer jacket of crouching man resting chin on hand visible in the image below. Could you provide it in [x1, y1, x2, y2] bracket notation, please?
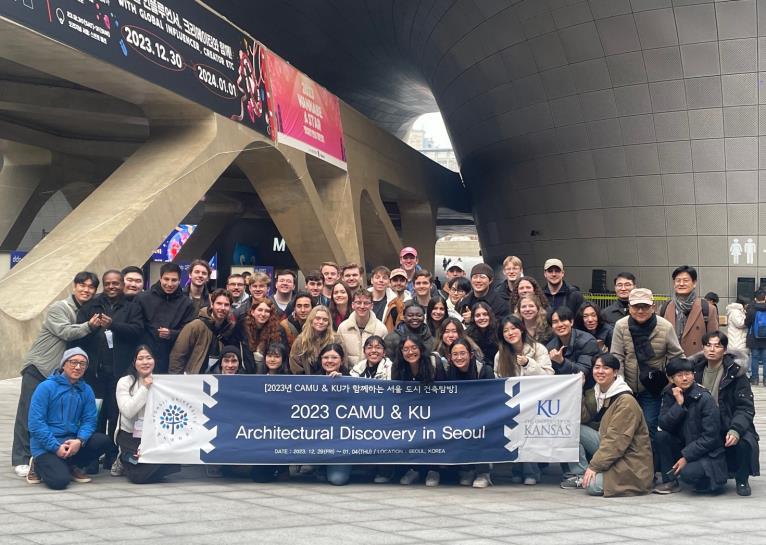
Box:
[660, 383, 728, 488]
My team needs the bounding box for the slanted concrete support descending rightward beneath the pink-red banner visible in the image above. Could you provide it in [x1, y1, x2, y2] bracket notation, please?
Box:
[236, 146, 358, 271]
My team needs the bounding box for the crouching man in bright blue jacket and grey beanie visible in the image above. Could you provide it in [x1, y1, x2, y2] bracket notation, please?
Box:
[27, 348, 109, 490]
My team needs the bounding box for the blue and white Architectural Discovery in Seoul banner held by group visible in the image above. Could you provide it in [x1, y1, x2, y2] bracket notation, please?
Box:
[140, 375, 582, 464]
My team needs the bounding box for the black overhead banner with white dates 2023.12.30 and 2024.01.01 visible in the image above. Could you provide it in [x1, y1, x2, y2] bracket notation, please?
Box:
[0, 0, 274, 138]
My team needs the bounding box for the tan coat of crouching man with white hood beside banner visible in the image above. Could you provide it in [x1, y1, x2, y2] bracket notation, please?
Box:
[583, 393, 654, 497]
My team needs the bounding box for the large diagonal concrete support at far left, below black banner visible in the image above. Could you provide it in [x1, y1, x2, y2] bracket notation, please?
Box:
[0, 113, 270, 377]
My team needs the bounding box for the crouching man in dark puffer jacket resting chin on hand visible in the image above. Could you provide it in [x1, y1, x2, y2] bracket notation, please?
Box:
[654, 358, 727, 494]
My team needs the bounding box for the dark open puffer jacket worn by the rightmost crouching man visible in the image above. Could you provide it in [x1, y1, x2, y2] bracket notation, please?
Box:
[690, 354, 761, 476]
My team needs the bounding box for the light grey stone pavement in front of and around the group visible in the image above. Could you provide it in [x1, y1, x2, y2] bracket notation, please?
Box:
[0, 379, 766, 545]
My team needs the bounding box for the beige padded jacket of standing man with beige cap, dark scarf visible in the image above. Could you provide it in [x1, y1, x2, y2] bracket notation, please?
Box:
[612, 316, 684, 394]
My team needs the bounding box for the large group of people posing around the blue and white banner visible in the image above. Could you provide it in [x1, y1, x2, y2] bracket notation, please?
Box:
[12, 247, 766, 496]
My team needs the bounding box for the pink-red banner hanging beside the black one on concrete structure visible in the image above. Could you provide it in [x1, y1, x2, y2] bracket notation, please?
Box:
[265, 49, 347, 170]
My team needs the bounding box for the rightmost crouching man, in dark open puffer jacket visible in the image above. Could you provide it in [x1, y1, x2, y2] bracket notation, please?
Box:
[692, 331, 760, 496]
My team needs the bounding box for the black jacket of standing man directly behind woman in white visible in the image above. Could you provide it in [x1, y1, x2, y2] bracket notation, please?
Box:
[134, 282, 195, 374]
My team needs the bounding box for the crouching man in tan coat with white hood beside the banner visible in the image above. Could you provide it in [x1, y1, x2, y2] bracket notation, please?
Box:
[582, 354, 654, 497]
